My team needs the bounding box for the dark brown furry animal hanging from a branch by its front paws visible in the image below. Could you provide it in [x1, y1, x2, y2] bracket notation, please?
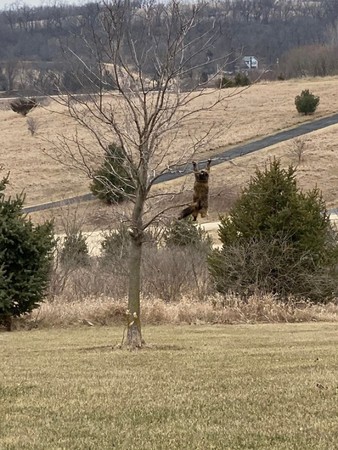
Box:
[178, 159, 211, 220]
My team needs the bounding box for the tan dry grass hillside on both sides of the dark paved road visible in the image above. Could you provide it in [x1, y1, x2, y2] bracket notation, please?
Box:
[0, 77, 338, 216]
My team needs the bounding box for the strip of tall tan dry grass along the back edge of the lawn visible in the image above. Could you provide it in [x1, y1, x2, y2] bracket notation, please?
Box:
[14, 295, 338, 329]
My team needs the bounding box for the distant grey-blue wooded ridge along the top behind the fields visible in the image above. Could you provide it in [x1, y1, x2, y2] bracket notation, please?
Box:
[0, 0, 338, 93]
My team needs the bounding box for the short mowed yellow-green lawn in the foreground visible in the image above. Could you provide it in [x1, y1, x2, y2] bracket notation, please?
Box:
[0, 323, 338, 450]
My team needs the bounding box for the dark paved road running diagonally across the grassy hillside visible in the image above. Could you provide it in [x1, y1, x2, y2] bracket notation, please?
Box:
[23, 114, 338, 213]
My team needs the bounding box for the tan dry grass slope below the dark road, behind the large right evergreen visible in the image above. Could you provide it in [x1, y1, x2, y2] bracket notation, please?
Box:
[156, 120, 338, 221]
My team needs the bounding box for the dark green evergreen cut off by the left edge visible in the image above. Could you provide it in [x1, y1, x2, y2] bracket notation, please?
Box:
[0, 176, 54, 330]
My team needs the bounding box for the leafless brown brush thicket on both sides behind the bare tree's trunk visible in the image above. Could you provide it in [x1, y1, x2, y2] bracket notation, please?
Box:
[49, 245, 210, 302]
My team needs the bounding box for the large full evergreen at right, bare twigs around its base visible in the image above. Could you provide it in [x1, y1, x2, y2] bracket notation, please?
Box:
[209, 160, 338, 301]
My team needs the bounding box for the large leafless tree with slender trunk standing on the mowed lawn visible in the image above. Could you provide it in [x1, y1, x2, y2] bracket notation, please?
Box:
[48, 0, 242, 348]
